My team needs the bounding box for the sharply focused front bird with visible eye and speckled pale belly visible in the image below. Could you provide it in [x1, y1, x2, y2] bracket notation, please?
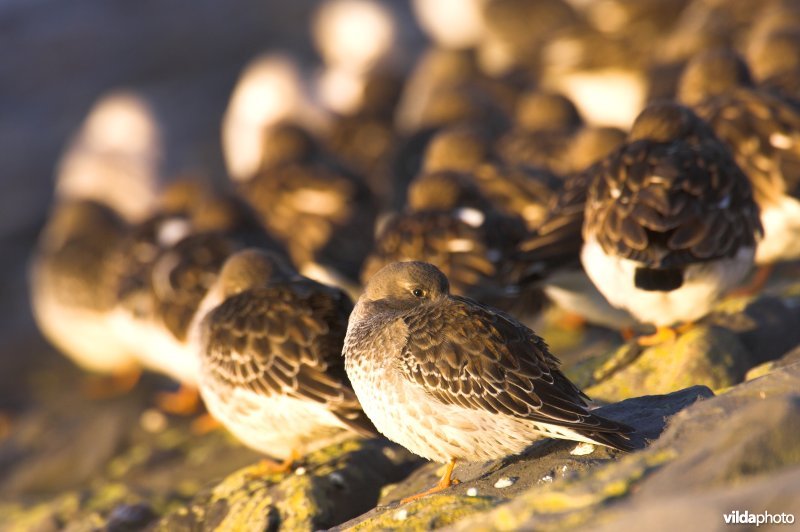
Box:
[344, 262, 632, 474]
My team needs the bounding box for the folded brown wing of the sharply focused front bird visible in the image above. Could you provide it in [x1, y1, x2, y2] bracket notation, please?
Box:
[399, 297, 631, 444]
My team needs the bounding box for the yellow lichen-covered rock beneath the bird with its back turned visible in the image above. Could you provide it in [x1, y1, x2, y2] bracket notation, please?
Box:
[566, 284, 800, 402]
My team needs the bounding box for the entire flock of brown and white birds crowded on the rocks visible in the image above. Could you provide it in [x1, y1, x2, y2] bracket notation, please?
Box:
[23, 0, 800, 502]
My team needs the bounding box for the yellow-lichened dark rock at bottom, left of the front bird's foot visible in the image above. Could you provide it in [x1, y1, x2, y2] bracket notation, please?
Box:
[154, 440, 419, 531]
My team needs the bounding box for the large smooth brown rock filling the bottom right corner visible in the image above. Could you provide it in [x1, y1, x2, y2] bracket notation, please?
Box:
[444, 363, 800, 531]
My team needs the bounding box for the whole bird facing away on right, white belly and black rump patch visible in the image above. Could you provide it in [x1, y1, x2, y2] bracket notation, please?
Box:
[581, 102, 762, 326]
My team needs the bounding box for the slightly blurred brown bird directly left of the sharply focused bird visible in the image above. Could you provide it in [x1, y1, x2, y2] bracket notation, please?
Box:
[197, 249, 374, 458]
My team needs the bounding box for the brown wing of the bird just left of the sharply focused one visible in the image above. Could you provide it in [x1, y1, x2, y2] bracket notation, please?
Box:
[201, 280, 374, 435]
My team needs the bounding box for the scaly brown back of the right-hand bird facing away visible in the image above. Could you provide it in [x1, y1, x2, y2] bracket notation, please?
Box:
[584, 140, 761, 268]
